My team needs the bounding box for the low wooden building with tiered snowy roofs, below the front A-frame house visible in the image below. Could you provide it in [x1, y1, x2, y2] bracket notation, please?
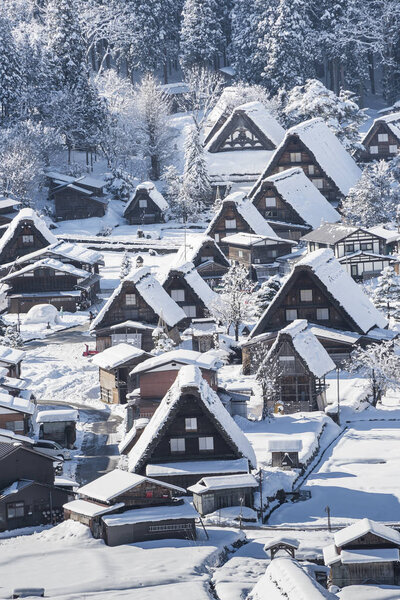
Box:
[64, 469, 198, 546]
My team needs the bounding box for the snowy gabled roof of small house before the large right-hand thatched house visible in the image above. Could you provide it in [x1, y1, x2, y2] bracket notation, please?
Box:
[267, 319, 335, 378]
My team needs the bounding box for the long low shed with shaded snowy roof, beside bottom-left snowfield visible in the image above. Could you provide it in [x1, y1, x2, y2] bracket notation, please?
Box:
[102, 499, 199, 546]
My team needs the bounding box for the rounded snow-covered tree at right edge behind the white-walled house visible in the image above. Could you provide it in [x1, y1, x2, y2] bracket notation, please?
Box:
[342, 160, 399, 227]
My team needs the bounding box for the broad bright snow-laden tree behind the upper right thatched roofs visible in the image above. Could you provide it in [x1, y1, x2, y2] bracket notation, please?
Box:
[283, 79, 367, 150]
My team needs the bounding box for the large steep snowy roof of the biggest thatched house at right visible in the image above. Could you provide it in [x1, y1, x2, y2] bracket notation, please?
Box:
[249, 249, 387, 338]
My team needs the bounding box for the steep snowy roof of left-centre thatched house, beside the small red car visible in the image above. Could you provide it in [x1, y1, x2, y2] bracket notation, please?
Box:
[90, 267, 186, 330]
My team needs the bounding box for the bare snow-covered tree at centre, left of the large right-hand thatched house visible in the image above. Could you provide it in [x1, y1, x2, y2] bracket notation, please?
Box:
[209, 264, 254, 341]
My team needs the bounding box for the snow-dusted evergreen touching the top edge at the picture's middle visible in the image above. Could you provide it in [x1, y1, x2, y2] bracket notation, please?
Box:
[180, 0, 224, 70]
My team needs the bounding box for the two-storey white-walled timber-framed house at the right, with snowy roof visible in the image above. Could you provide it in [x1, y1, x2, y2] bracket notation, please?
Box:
[301, 223, 397, 281]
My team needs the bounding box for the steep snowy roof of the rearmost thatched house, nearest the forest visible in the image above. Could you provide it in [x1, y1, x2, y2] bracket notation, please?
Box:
[206, 102, 285, 153]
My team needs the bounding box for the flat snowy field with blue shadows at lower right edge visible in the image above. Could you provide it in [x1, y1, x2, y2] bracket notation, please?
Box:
[269, 421, 400, 525]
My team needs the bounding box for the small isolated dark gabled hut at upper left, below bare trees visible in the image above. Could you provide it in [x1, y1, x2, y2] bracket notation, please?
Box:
[124, 181, 169, 225]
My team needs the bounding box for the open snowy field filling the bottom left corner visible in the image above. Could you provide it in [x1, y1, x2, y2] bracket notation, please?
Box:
[0, 521, 244, 600]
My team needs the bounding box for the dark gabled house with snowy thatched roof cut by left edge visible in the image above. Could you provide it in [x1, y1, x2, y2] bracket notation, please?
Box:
[0, 208, 57, 264]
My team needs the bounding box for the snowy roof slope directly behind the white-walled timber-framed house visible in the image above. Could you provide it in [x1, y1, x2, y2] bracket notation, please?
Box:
[264, 167, 340, 229]
